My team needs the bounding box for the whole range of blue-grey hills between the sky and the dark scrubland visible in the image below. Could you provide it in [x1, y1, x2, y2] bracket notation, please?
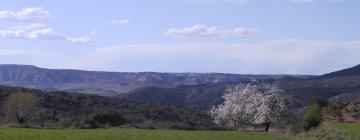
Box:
[0, 65, 360, 108]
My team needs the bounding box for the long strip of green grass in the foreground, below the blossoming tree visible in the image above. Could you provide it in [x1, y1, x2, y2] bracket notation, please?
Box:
[0, 128, 308, 140]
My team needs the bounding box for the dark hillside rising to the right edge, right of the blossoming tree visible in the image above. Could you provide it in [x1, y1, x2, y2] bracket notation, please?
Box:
[280, 65, 360, 102]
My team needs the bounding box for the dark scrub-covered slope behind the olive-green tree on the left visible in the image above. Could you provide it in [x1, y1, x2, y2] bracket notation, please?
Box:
[0, 86, 215, 129]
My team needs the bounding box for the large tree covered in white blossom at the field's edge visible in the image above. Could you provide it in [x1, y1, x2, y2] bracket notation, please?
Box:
[209, 84, 291, 132]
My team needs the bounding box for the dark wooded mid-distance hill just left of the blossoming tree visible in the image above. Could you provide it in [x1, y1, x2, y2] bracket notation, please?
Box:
[118, 84, 229, 108]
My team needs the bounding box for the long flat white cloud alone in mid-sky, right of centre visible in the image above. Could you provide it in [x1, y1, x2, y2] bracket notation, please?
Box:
[166, 25, 257, 37]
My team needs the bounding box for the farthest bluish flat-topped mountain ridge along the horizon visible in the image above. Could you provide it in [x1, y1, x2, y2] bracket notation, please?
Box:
[0, 64, 312, 96]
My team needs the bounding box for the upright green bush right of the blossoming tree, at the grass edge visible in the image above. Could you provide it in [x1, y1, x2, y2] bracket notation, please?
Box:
[303, 104, 322, 131]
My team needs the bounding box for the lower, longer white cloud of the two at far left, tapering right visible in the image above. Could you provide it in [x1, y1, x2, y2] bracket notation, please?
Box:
[0, 24, 90, 43]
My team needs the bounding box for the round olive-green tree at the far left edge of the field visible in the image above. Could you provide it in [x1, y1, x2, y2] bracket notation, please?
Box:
[3, 92, 39, 125]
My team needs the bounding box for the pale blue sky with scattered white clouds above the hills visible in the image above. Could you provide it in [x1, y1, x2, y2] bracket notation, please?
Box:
[0, 0, 360, 75]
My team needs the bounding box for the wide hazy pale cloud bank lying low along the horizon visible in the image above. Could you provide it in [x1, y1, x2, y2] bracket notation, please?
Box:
[0, 39, 360, 74]
